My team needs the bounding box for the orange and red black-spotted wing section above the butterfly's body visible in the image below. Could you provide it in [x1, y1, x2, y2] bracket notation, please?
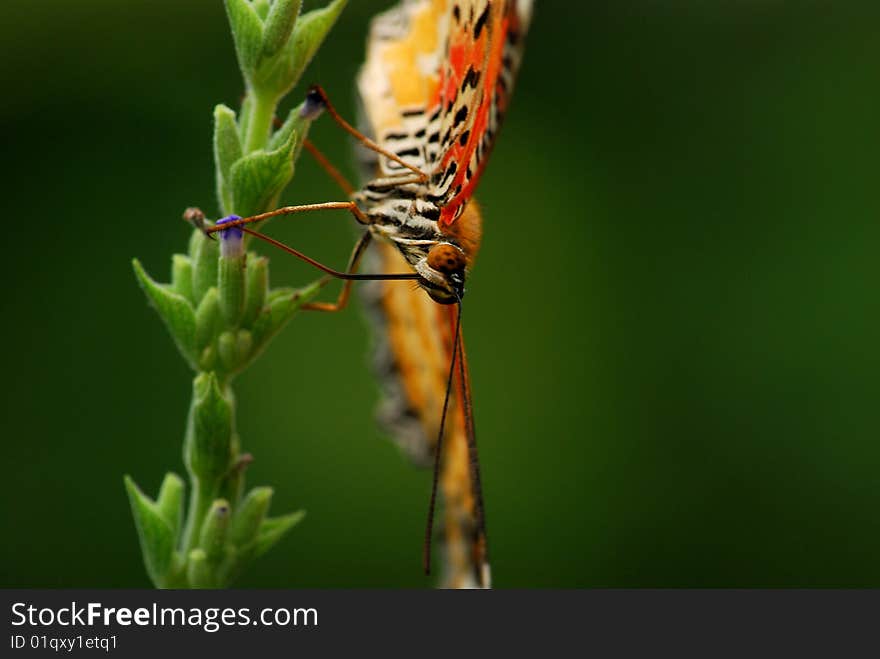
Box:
[358, 0, 532, 195]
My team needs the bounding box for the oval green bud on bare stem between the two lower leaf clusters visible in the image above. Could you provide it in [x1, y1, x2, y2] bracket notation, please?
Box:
[183, 372, 235, 484]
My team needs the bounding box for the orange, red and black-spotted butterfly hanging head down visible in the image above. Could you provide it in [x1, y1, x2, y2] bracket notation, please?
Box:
[205, 0, 532, 587]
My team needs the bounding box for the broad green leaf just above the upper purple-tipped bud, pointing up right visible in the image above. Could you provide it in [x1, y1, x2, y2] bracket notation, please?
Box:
[230, 130, 296, 217]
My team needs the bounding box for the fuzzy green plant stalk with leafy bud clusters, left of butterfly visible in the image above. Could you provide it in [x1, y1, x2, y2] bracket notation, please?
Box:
[124, 0, 346, 588]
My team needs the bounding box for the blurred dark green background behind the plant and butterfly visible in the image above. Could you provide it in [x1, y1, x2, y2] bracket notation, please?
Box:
[0, 0, 880, 587]
